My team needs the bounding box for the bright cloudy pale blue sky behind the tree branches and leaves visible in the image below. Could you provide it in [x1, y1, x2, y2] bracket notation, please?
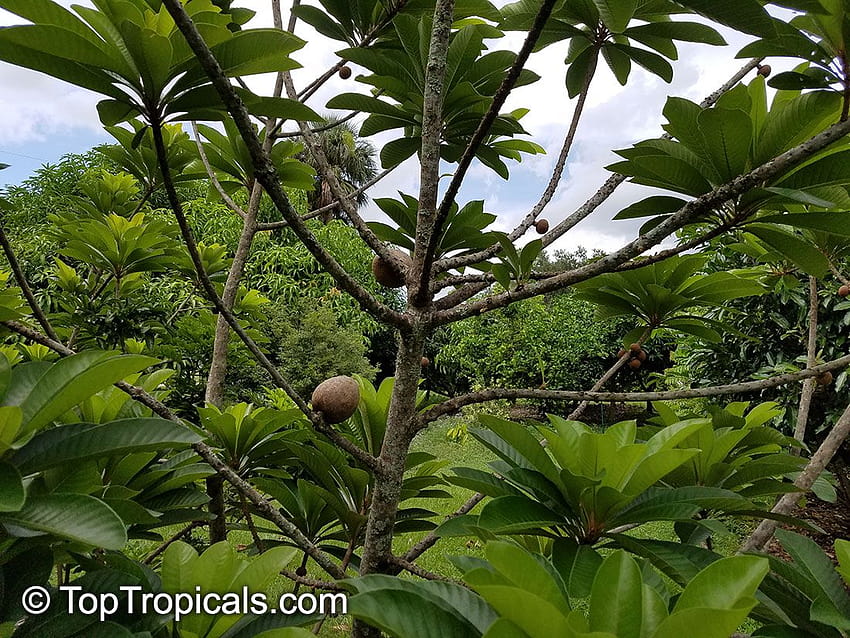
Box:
[0, 0, 787, 258]
